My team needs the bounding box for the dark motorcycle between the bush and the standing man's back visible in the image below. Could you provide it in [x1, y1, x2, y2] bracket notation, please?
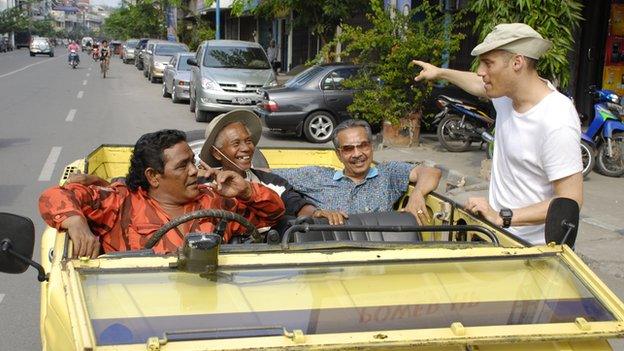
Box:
[433, 95, 495, 154]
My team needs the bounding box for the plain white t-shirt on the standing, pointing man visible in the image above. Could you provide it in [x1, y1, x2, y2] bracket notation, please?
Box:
[489, 82, 583, 244]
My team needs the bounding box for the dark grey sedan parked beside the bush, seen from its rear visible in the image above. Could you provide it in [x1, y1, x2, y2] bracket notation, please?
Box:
[254, 64, 357, 143]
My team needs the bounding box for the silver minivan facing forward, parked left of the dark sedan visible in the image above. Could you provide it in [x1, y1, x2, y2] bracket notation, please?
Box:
[188, 40, 277, 122]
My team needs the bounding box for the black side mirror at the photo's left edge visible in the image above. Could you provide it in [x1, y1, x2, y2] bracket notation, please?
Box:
[0, 213, 35, 274]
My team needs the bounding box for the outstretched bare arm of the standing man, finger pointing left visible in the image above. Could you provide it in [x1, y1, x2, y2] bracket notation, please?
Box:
[412, 60, 488, 98]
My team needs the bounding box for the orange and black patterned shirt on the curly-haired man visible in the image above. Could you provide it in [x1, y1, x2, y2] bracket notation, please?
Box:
[39, 183, 284, 254]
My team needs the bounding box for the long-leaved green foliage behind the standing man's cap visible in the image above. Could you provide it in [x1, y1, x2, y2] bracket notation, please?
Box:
[469, 0, 583, 88]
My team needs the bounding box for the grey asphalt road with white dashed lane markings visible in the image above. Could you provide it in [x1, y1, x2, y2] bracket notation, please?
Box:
[0, 47, 332, 350]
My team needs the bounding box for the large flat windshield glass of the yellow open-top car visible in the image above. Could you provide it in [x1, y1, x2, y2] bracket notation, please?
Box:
[81, 256, 615, 345]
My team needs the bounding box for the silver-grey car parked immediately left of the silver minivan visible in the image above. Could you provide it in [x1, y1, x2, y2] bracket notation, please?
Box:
[163, 52, 195, 103]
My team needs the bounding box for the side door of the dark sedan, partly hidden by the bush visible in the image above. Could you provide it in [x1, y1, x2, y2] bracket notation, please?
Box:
[321, 67, 357, 119]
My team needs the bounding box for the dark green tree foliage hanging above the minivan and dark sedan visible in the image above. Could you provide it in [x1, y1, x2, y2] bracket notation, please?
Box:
[232, 0, 370, 44]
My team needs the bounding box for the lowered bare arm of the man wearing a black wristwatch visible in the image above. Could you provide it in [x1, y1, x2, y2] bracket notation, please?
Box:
[466, 173, 583, 226]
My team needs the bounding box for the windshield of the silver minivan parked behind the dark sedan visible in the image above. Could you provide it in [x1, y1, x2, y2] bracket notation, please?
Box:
[203, 46, 271, 69]
